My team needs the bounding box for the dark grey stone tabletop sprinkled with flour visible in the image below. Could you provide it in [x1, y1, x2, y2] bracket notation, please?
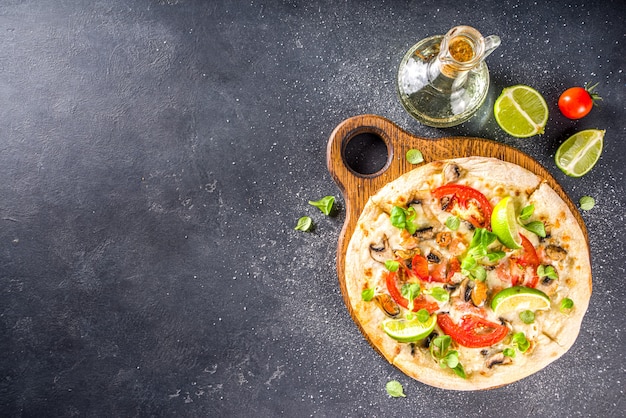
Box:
[0, 0, 626, 417]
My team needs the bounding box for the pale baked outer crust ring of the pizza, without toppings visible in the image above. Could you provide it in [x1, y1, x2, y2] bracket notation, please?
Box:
[345, 157, 591, 390]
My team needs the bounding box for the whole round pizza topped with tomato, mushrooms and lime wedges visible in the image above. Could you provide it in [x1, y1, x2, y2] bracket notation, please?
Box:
[344, 157, 591, 390]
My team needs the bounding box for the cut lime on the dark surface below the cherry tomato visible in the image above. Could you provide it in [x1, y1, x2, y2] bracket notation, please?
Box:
[554, 129, 606, 177]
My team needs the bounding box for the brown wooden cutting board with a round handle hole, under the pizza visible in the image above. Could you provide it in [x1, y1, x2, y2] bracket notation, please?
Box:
[326, 115, 588, 336]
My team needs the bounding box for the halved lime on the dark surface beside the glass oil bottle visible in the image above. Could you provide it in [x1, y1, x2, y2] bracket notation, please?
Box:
[493, 84, 548, 138]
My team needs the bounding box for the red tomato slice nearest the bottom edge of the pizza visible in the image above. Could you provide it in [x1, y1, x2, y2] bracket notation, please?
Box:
[437, 314, 509, 348]
